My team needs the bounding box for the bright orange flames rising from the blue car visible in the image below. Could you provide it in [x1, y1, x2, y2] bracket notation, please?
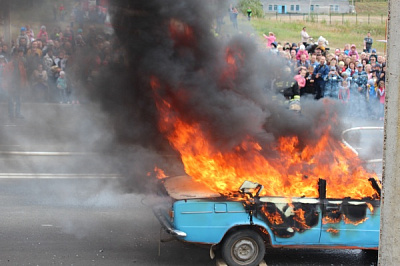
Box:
[150, 20, 377, 200]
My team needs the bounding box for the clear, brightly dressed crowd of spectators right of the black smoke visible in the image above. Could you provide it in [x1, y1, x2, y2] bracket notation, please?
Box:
[264, 27, 386, 120]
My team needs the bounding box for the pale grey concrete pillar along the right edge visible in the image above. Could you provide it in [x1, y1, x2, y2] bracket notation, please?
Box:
[378, 0, 400, 266]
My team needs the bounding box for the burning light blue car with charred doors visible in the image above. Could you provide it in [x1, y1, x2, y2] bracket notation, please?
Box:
[153, 176, 381, 266]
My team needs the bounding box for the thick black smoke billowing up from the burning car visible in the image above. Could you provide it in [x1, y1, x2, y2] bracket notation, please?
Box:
[95, 0, 346, 191]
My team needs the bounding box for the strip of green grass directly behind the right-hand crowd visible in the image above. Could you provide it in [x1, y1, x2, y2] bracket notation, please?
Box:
[251, 18, 386, 53]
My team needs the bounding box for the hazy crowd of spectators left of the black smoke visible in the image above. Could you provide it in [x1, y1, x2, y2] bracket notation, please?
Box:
[0, 2, 122, 119]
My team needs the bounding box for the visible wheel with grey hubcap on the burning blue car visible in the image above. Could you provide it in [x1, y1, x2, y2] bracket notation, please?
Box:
[221, 230, 265, 266]
